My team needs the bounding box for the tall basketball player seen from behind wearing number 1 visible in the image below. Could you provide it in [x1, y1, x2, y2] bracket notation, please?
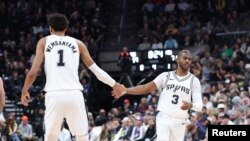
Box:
[21, 13, 122, 141]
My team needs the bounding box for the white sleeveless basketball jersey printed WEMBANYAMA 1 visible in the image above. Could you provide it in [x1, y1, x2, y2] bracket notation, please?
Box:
[44, 35, 83, 92]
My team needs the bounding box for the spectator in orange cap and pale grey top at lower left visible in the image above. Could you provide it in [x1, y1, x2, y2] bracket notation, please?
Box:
[18, 115, 39, 141]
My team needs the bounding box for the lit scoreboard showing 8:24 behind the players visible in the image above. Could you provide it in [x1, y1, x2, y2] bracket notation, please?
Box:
[130, 49, 179, 71]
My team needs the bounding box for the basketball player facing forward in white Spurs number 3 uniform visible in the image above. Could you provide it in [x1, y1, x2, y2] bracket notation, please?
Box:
[112, 50, 202, 141]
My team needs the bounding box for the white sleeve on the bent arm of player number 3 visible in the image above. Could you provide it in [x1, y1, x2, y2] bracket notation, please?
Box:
[191, 77, 203, 111]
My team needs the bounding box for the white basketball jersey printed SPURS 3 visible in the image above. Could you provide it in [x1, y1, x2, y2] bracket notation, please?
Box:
[154, 71, 194, 118]
